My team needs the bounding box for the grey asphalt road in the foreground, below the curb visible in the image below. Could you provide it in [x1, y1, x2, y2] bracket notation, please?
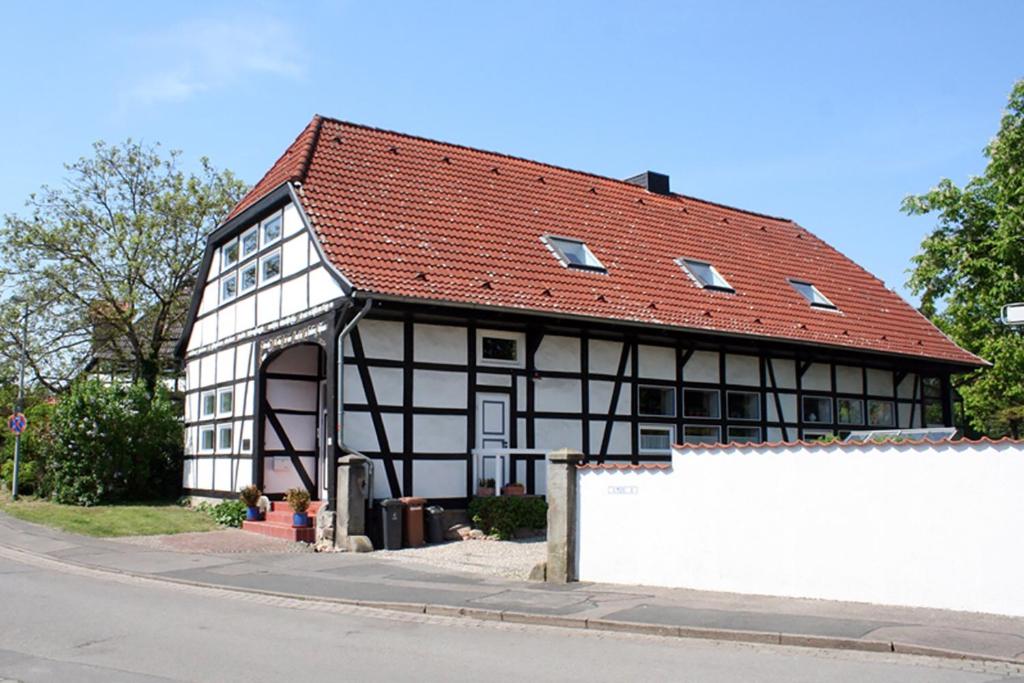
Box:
[0, 557, 1024, 683]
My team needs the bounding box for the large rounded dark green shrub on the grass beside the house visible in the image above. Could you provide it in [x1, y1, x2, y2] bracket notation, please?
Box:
[45, 380, 182, 505]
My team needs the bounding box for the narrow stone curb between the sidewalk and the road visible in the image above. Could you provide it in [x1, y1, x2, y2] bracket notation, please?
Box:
[0, 544, 1024, 663]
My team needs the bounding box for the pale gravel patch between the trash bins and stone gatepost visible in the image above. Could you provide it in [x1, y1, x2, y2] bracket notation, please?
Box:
[373, 539, 547, 580]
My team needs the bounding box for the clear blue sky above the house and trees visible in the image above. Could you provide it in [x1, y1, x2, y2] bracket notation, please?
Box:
[0, 0, 1024, 295]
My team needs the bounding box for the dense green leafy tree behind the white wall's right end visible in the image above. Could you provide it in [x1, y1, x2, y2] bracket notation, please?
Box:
[903, 80, 1024, 436]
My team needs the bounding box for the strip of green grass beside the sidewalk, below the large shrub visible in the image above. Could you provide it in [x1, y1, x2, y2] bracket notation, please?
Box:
[0, 497, 217, 537]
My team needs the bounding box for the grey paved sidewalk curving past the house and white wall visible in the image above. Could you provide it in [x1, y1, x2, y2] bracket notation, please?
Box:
[0, 513, 1024, 664]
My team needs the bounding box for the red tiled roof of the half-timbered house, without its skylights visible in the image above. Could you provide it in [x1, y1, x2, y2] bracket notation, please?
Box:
[220, 117, 984, 366]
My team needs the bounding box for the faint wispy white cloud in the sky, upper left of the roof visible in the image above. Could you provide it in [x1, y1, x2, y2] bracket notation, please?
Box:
[124, 17, 305, 104]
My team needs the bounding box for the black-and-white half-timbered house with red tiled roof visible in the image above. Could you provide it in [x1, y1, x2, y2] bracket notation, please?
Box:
[178, 117, 984, 507]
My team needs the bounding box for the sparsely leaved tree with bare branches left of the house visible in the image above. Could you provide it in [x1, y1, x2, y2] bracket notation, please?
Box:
[0, 139, 246, 393]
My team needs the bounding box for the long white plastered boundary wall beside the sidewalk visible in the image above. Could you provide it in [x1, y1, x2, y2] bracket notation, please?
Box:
[577, 441, 1024, 615]
